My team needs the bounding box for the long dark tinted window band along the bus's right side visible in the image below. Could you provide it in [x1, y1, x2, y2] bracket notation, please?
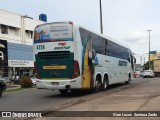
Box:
[79, 28, 130, 61]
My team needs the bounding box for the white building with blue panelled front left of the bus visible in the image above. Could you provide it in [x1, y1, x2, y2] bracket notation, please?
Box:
[0, 10, 44, 78]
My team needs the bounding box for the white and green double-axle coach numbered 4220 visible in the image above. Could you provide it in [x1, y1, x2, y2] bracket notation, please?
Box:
[33, 22, 134, 94]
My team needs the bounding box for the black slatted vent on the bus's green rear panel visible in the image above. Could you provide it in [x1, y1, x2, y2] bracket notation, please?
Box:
[38, 51, 70, 59]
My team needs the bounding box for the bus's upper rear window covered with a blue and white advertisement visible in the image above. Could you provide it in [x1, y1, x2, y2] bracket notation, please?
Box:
[34, 23, 73, 43]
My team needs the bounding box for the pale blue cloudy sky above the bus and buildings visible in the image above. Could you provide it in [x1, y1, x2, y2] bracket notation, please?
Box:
[0, 0, 160, 63]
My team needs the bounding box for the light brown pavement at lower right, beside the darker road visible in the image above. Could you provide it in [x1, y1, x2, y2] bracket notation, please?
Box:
[36, 78, 160, 120]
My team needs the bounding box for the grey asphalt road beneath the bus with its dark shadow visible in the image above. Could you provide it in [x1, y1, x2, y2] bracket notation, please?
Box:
[0, 78, 155, 111]
